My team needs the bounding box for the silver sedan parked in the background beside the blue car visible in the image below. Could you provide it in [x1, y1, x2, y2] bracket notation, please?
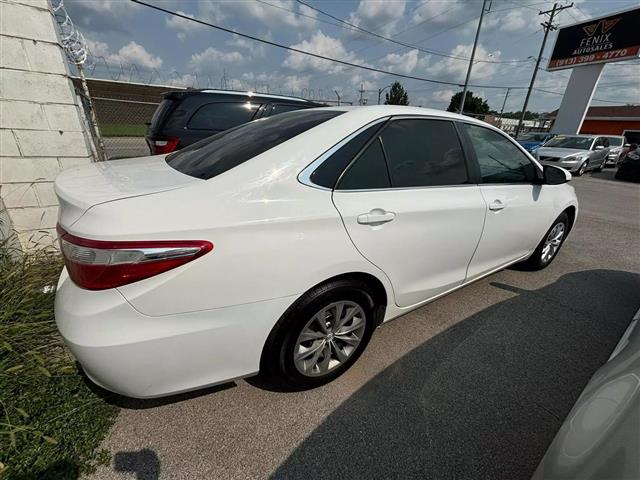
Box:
[535, 135, 610, 177]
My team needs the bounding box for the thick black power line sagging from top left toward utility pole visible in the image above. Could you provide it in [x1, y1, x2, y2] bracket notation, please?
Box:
[131, 0, 526, 89]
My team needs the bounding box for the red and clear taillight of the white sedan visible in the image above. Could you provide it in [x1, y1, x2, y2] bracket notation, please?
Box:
[58, 226, 213, 290]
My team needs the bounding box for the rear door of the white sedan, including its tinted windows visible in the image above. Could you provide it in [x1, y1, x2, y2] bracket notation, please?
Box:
[333, 117, 486, 307]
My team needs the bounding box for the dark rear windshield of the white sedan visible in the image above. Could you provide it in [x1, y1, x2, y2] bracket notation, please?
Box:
[166, 110, 344, 180]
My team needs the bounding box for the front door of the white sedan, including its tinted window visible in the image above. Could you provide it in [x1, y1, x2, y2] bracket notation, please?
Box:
[462, 124, 555, 280]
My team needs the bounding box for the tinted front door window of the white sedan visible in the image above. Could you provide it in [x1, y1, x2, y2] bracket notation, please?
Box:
[465, 124, 537, 183]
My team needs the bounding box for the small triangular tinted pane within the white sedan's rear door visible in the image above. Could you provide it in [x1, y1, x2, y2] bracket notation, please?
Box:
[338, 138, 391, 190]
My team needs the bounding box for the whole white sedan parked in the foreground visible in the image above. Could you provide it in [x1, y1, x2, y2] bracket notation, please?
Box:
[55, 106, 578, 398]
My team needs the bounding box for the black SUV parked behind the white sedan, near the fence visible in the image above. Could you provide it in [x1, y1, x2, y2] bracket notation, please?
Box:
[146, 90, 325, 155]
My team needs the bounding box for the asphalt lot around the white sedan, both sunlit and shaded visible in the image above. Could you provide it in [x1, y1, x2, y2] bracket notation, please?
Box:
[93, 169, 640, 480]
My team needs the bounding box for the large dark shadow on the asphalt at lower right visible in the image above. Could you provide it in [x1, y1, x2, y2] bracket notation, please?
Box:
[271, 270, 640, 480]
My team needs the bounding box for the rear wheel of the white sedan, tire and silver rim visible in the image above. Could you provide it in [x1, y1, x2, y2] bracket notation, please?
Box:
[260, 279, 378, 390]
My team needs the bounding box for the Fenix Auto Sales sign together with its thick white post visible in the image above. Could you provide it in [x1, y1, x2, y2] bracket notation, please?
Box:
[547, 7, 640, 134]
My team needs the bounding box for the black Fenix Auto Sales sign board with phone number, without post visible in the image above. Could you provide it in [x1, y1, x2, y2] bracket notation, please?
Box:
[547, 8, 640, 70]
